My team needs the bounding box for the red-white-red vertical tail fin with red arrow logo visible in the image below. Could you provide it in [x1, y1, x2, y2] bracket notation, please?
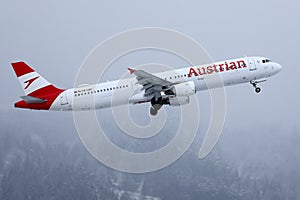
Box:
[11, 62, 63, 98]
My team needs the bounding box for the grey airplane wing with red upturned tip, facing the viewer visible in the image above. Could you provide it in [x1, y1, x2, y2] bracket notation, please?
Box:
[128, 68, 174, 98]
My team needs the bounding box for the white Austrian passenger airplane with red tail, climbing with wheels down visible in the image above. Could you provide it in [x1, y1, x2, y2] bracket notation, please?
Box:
[12, 57, 282, 116]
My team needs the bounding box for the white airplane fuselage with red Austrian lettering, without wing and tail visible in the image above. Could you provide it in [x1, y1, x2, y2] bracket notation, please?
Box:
[50, 57, 281, 111]
